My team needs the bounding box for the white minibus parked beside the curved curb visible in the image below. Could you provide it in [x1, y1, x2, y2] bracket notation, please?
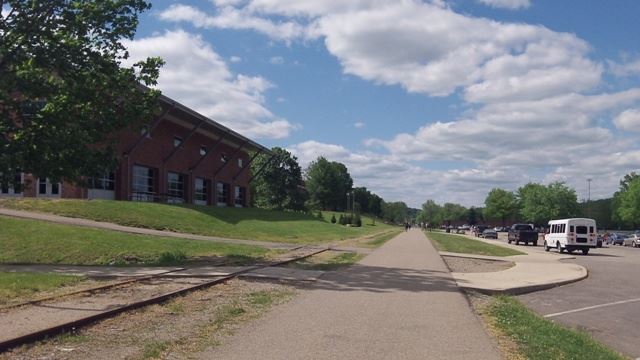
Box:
[544, 218, 598, 255]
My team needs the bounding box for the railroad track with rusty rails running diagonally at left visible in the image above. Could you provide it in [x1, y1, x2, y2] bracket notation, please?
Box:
[0, 247, 329, 352]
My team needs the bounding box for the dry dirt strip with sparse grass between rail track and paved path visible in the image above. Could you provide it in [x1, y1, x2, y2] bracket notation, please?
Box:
[0, 279, 295, 360]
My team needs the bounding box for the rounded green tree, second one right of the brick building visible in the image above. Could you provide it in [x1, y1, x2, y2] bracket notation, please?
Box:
[306, 156, 353, 211]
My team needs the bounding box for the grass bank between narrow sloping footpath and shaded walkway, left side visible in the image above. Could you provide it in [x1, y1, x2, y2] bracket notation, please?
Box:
[0, 216, 271, 265]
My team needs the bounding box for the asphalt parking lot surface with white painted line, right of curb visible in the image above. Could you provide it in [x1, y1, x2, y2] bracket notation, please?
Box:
[518, 246, 640, 358]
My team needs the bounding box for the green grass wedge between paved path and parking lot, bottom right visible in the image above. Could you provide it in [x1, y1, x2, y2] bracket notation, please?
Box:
[486, 296, 624, 360]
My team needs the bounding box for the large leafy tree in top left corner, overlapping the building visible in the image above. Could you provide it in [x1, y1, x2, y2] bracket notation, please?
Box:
[0, 0, 162, 183]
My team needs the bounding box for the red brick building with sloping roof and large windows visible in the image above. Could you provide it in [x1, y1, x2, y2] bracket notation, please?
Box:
[0, 96, 269, 207]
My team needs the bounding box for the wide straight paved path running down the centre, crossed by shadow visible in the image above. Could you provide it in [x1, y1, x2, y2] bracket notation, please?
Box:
[200, 230, 500, 359]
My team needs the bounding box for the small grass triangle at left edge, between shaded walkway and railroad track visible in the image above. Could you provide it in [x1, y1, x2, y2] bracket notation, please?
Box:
[0, 272, 84, 303]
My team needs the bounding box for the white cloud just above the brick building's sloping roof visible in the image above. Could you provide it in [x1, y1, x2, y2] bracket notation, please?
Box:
[124, 30, 296, 138]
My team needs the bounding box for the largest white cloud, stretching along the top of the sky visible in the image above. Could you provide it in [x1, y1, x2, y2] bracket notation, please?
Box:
[160, 0, 602, 102]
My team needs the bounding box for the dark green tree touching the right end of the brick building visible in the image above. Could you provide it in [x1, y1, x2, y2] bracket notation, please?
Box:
[251, 147, 307, 211]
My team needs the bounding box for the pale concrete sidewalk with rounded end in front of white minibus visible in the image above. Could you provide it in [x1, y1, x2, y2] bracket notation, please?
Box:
[440, 235, 588, 295]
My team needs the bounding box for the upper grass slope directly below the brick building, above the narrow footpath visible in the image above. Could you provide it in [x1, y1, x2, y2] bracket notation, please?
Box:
[0, 198, 391, 244]
